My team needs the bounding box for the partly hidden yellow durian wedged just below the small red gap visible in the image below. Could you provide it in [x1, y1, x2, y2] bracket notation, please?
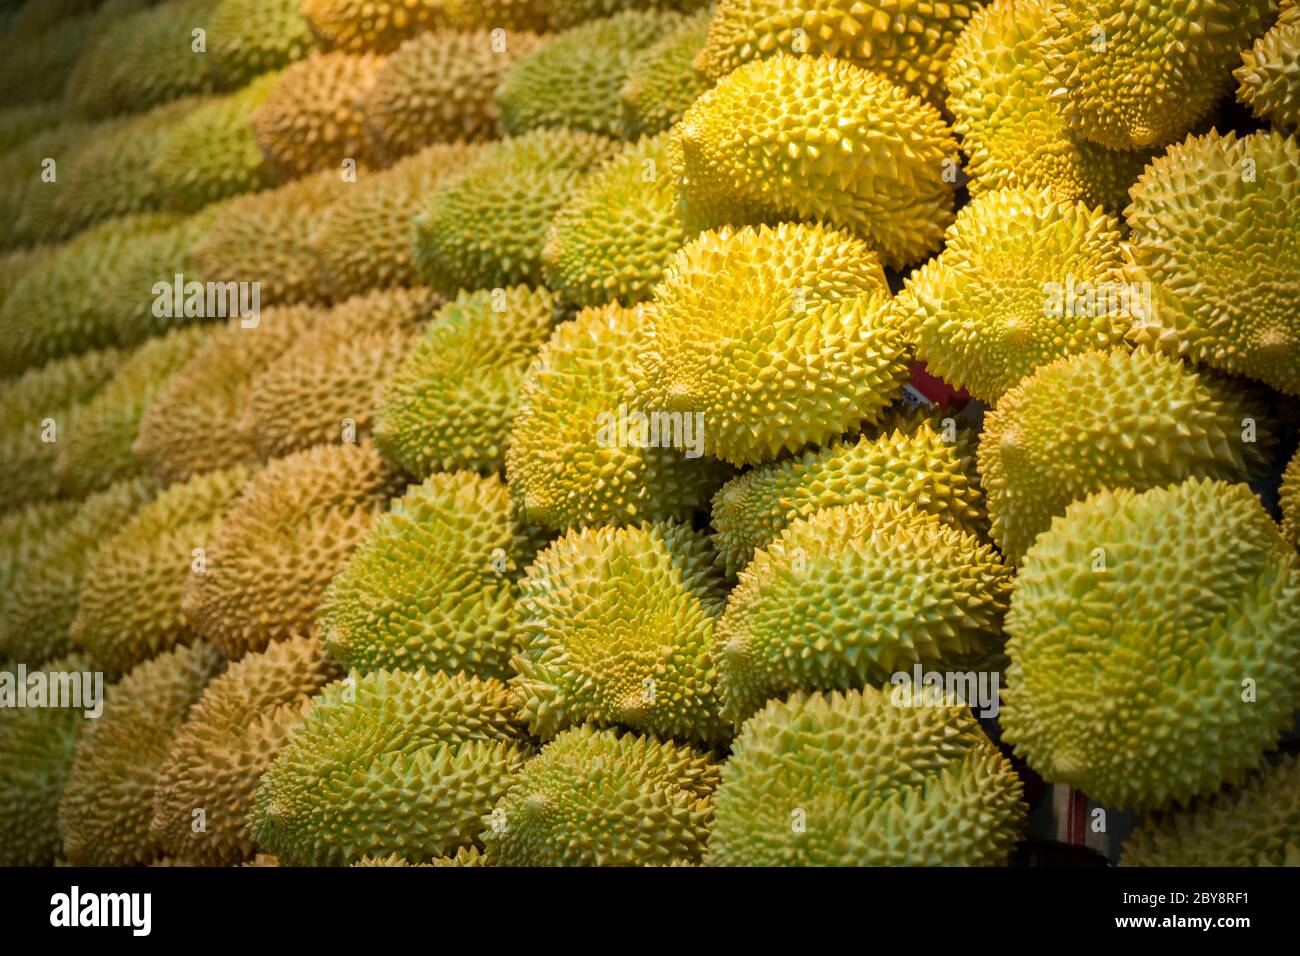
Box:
[712, 415, 988, 575]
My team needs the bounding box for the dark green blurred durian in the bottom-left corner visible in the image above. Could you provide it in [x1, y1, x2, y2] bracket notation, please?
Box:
[0, 656, 94, 866]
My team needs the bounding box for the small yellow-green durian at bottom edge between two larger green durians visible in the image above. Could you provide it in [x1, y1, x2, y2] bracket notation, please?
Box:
[481, 726, 718, 866]
